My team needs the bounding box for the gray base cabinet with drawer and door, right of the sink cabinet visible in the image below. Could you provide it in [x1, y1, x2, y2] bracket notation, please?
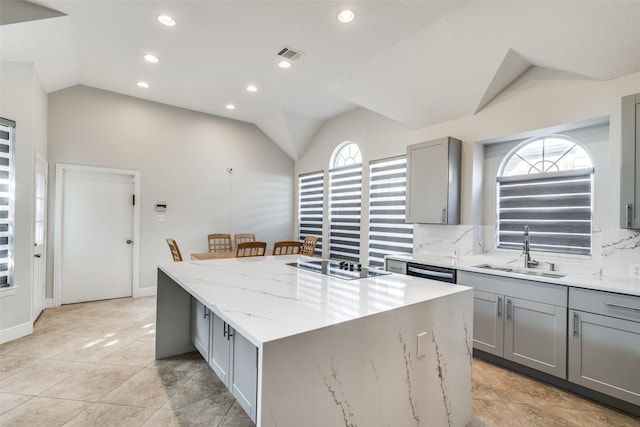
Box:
[569, 288, 640, 405]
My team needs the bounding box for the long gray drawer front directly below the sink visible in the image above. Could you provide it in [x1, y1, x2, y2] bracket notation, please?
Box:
[458, 270, 567, 307]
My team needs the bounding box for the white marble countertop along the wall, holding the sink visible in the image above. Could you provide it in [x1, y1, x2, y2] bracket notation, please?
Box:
[387, 255, 640, 296]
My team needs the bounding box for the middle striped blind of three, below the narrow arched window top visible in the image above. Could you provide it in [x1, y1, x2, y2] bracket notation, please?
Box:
[329, 165, 362, 262]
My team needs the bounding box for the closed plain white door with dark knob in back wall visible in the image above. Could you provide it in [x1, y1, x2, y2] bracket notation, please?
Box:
[60, 169, 135, 304]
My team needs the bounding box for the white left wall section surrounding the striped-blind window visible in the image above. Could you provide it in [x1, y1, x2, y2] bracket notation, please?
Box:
[0, 62, 47, 343]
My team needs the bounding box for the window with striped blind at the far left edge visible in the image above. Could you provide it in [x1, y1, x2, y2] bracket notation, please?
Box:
[0, 118, 15, 288]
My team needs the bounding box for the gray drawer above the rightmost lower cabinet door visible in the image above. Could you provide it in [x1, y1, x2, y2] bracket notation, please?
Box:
[569, 288, 640, 322]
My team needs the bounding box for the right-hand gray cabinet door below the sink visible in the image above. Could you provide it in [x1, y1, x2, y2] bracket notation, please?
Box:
[504, 297, 567, 378]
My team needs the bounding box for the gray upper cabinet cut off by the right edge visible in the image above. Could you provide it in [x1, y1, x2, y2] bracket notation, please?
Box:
[620, 94, 640, 229]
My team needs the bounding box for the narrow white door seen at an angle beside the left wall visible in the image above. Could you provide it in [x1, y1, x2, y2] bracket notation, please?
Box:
[32, 154, 49, 322]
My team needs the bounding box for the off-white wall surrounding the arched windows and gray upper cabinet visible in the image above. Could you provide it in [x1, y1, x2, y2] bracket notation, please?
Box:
[296, 68, 640, 274]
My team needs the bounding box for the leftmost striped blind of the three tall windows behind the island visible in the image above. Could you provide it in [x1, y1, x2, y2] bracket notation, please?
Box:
[298, 171, 324, 256]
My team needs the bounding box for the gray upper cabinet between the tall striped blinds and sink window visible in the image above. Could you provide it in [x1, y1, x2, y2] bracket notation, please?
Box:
[406, 137, 462, 224]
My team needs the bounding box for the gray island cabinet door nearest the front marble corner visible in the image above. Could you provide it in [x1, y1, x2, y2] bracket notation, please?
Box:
[231, 333, 258, 422]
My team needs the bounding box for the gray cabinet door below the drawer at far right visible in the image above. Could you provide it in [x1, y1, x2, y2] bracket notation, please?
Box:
[569, 310, 640, 405]
